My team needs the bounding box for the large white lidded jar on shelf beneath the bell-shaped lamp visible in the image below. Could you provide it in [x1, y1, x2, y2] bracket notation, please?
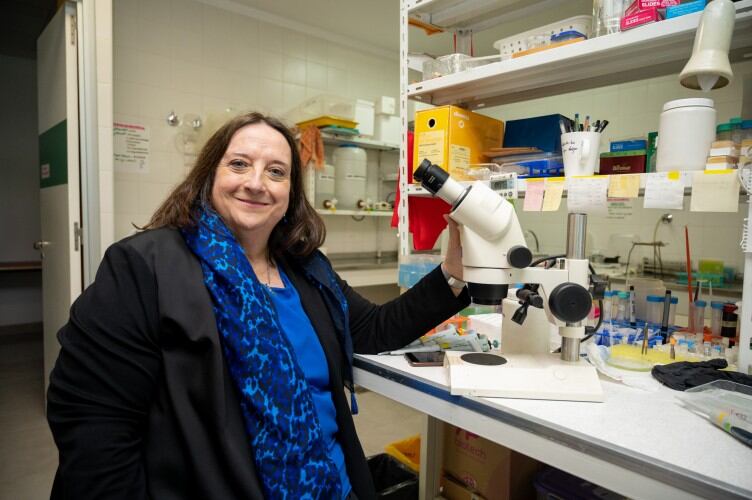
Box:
[655, 98, 715, 172]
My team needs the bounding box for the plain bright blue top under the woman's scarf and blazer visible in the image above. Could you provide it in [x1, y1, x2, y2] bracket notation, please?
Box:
[270, 268, 352, 499]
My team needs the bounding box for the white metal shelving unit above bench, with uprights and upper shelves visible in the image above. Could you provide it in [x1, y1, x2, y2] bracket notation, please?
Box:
[399, 0, 752, 369]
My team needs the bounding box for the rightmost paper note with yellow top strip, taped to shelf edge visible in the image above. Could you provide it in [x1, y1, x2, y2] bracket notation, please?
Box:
[689, 170, 740, 212]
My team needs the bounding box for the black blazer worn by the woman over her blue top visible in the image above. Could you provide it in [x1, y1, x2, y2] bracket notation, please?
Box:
[47, 229, 469, 500]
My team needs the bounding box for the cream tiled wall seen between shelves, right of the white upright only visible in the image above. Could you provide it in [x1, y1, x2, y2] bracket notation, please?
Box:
[484, 62, 752, 271]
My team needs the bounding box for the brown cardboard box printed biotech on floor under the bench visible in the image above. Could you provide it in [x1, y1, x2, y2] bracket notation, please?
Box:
[443, 425, 543, 500]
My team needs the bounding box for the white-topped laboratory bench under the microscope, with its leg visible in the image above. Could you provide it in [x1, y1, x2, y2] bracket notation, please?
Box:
[354, 355, 752, 499]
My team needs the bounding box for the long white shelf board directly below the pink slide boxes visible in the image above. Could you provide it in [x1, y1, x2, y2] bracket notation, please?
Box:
[403, 0, 752, 109]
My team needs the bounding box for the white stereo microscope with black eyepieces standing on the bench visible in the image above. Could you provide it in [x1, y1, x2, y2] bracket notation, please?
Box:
[413, 160, 603, 401]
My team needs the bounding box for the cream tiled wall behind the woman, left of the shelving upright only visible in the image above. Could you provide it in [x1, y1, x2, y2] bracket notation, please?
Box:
[113, 0, 399, 252]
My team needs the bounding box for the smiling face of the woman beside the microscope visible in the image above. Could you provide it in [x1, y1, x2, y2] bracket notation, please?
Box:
[211, 123, 292, 243]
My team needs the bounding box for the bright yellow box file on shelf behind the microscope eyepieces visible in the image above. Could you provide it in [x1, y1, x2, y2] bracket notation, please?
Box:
[413, 106, 504, 180]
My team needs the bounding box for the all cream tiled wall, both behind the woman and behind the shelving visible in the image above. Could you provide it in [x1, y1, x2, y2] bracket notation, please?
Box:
[114, 0, 752, 265]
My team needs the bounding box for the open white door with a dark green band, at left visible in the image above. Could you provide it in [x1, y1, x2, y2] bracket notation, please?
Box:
[35, 3, 83, 391]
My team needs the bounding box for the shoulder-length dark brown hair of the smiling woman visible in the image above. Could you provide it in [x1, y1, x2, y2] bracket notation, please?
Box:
[144, 112, 326, 257]
